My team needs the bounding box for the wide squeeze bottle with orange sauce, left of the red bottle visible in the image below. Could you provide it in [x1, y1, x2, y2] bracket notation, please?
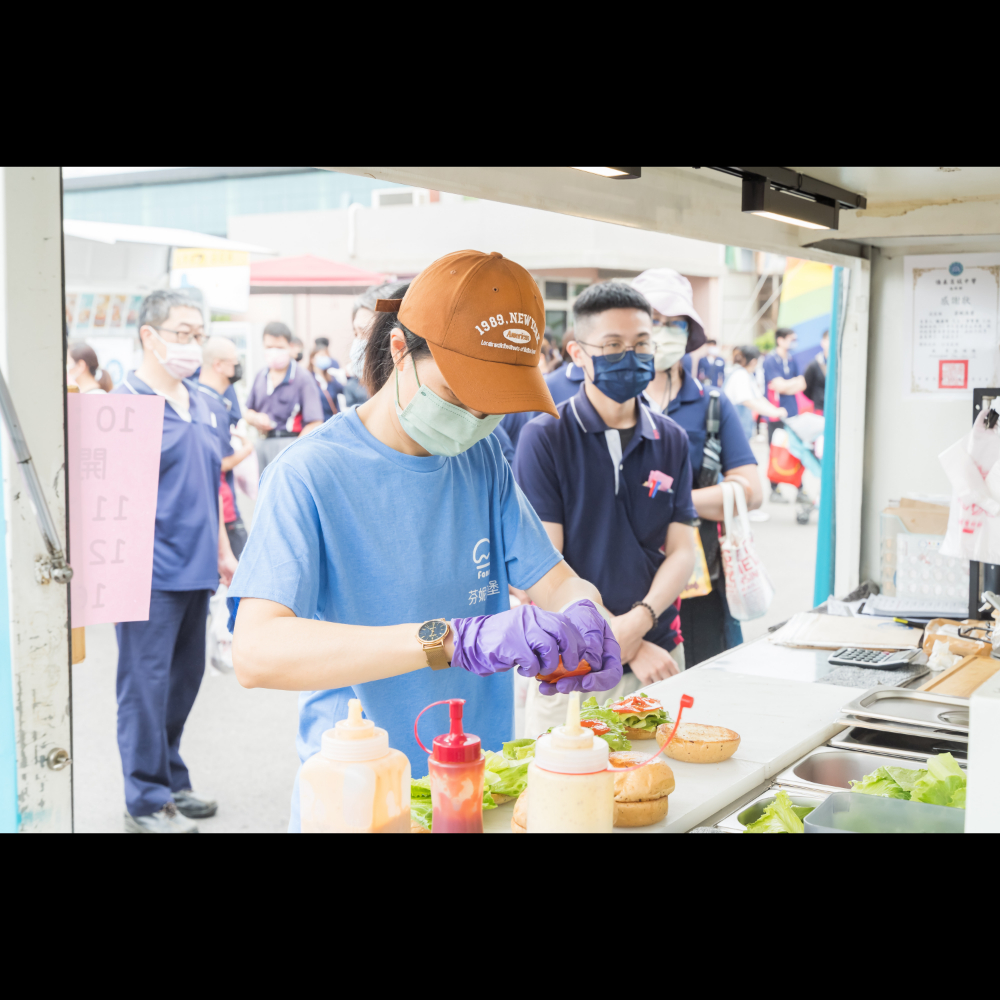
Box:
[299, 698, 410, 833]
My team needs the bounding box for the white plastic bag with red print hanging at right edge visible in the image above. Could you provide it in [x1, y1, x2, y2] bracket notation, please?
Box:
[938, 410, 1000, 563]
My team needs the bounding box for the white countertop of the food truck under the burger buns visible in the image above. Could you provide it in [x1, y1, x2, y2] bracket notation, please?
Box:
[483, 639, 863, 833]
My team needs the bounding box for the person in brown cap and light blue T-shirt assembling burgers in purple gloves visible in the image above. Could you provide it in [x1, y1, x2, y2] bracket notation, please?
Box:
[229, 251, 622, 829]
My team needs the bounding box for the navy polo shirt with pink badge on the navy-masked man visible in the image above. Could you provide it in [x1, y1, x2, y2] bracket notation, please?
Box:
[514, 389, 698, 650]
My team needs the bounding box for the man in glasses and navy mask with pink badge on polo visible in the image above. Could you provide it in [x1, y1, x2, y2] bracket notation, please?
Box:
[514, 281, 697, 736]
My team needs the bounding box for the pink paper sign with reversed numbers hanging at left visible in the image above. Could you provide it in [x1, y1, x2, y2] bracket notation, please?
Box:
[67, 393, 164, 628]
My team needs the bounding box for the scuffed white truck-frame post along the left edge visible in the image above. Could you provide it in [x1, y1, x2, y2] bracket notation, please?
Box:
[0, 167, 73, 833]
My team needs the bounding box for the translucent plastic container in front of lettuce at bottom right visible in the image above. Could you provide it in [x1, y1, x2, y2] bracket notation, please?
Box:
[802, 792, 965, 833]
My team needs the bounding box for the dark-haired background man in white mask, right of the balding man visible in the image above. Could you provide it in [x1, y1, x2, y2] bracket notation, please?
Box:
[245, 322, 323, 472]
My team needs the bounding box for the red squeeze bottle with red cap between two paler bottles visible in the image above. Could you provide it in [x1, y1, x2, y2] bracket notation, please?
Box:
[428, 698, 486, 833]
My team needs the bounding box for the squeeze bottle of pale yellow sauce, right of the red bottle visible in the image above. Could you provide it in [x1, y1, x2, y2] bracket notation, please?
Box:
[527, 691, 615, 833]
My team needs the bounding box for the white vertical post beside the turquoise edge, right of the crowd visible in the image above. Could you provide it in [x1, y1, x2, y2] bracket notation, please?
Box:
[834, 258, 871, 597]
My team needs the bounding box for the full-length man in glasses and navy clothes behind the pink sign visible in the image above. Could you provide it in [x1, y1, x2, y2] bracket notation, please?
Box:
[114, 291, 236, 833]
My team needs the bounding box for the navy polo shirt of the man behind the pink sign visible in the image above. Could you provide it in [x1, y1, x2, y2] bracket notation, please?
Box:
[113, 371, 222, 590]
